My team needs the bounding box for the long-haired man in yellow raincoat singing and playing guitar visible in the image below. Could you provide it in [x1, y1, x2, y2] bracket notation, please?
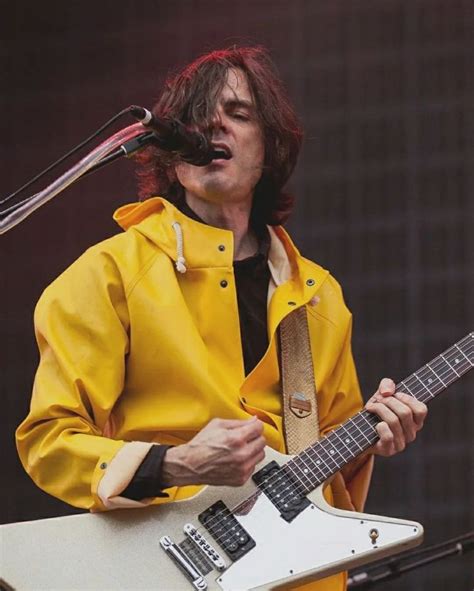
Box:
[17, 48, 426, 590]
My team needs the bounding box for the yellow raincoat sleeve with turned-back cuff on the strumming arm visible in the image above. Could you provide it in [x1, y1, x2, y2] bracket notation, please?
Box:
[16, 251, 160, 510]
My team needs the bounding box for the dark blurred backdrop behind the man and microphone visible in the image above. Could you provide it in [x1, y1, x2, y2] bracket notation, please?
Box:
[0, 0, 474, 591]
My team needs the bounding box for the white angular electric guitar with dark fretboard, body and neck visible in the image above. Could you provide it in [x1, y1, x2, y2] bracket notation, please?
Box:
[0, 332, 474, 591]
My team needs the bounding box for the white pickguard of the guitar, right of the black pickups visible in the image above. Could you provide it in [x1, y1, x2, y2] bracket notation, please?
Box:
[217, 488, 423, 591]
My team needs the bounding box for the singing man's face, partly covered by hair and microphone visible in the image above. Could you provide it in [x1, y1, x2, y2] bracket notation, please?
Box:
[176, 69, 265, 208]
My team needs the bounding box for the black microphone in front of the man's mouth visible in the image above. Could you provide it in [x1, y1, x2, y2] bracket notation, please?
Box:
[130, 105, 214, 166]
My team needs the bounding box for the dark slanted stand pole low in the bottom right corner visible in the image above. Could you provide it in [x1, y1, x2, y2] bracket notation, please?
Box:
[347, 532, 474, 589]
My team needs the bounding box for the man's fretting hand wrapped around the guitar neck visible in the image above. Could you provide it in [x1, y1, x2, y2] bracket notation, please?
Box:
[365, 378, 428, 456]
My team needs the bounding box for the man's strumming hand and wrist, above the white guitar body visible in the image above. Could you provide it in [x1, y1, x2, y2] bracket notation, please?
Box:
[162, 417, 265, 487]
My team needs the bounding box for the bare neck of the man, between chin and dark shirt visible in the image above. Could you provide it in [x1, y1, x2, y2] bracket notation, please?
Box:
[186, 193, 258, 260]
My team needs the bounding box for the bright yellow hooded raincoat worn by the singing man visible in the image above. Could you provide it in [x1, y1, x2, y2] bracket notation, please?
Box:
[17, 198, 371, 591]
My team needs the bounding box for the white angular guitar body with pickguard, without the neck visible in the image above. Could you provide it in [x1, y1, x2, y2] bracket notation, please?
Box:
[0, 448, 423, 591]
